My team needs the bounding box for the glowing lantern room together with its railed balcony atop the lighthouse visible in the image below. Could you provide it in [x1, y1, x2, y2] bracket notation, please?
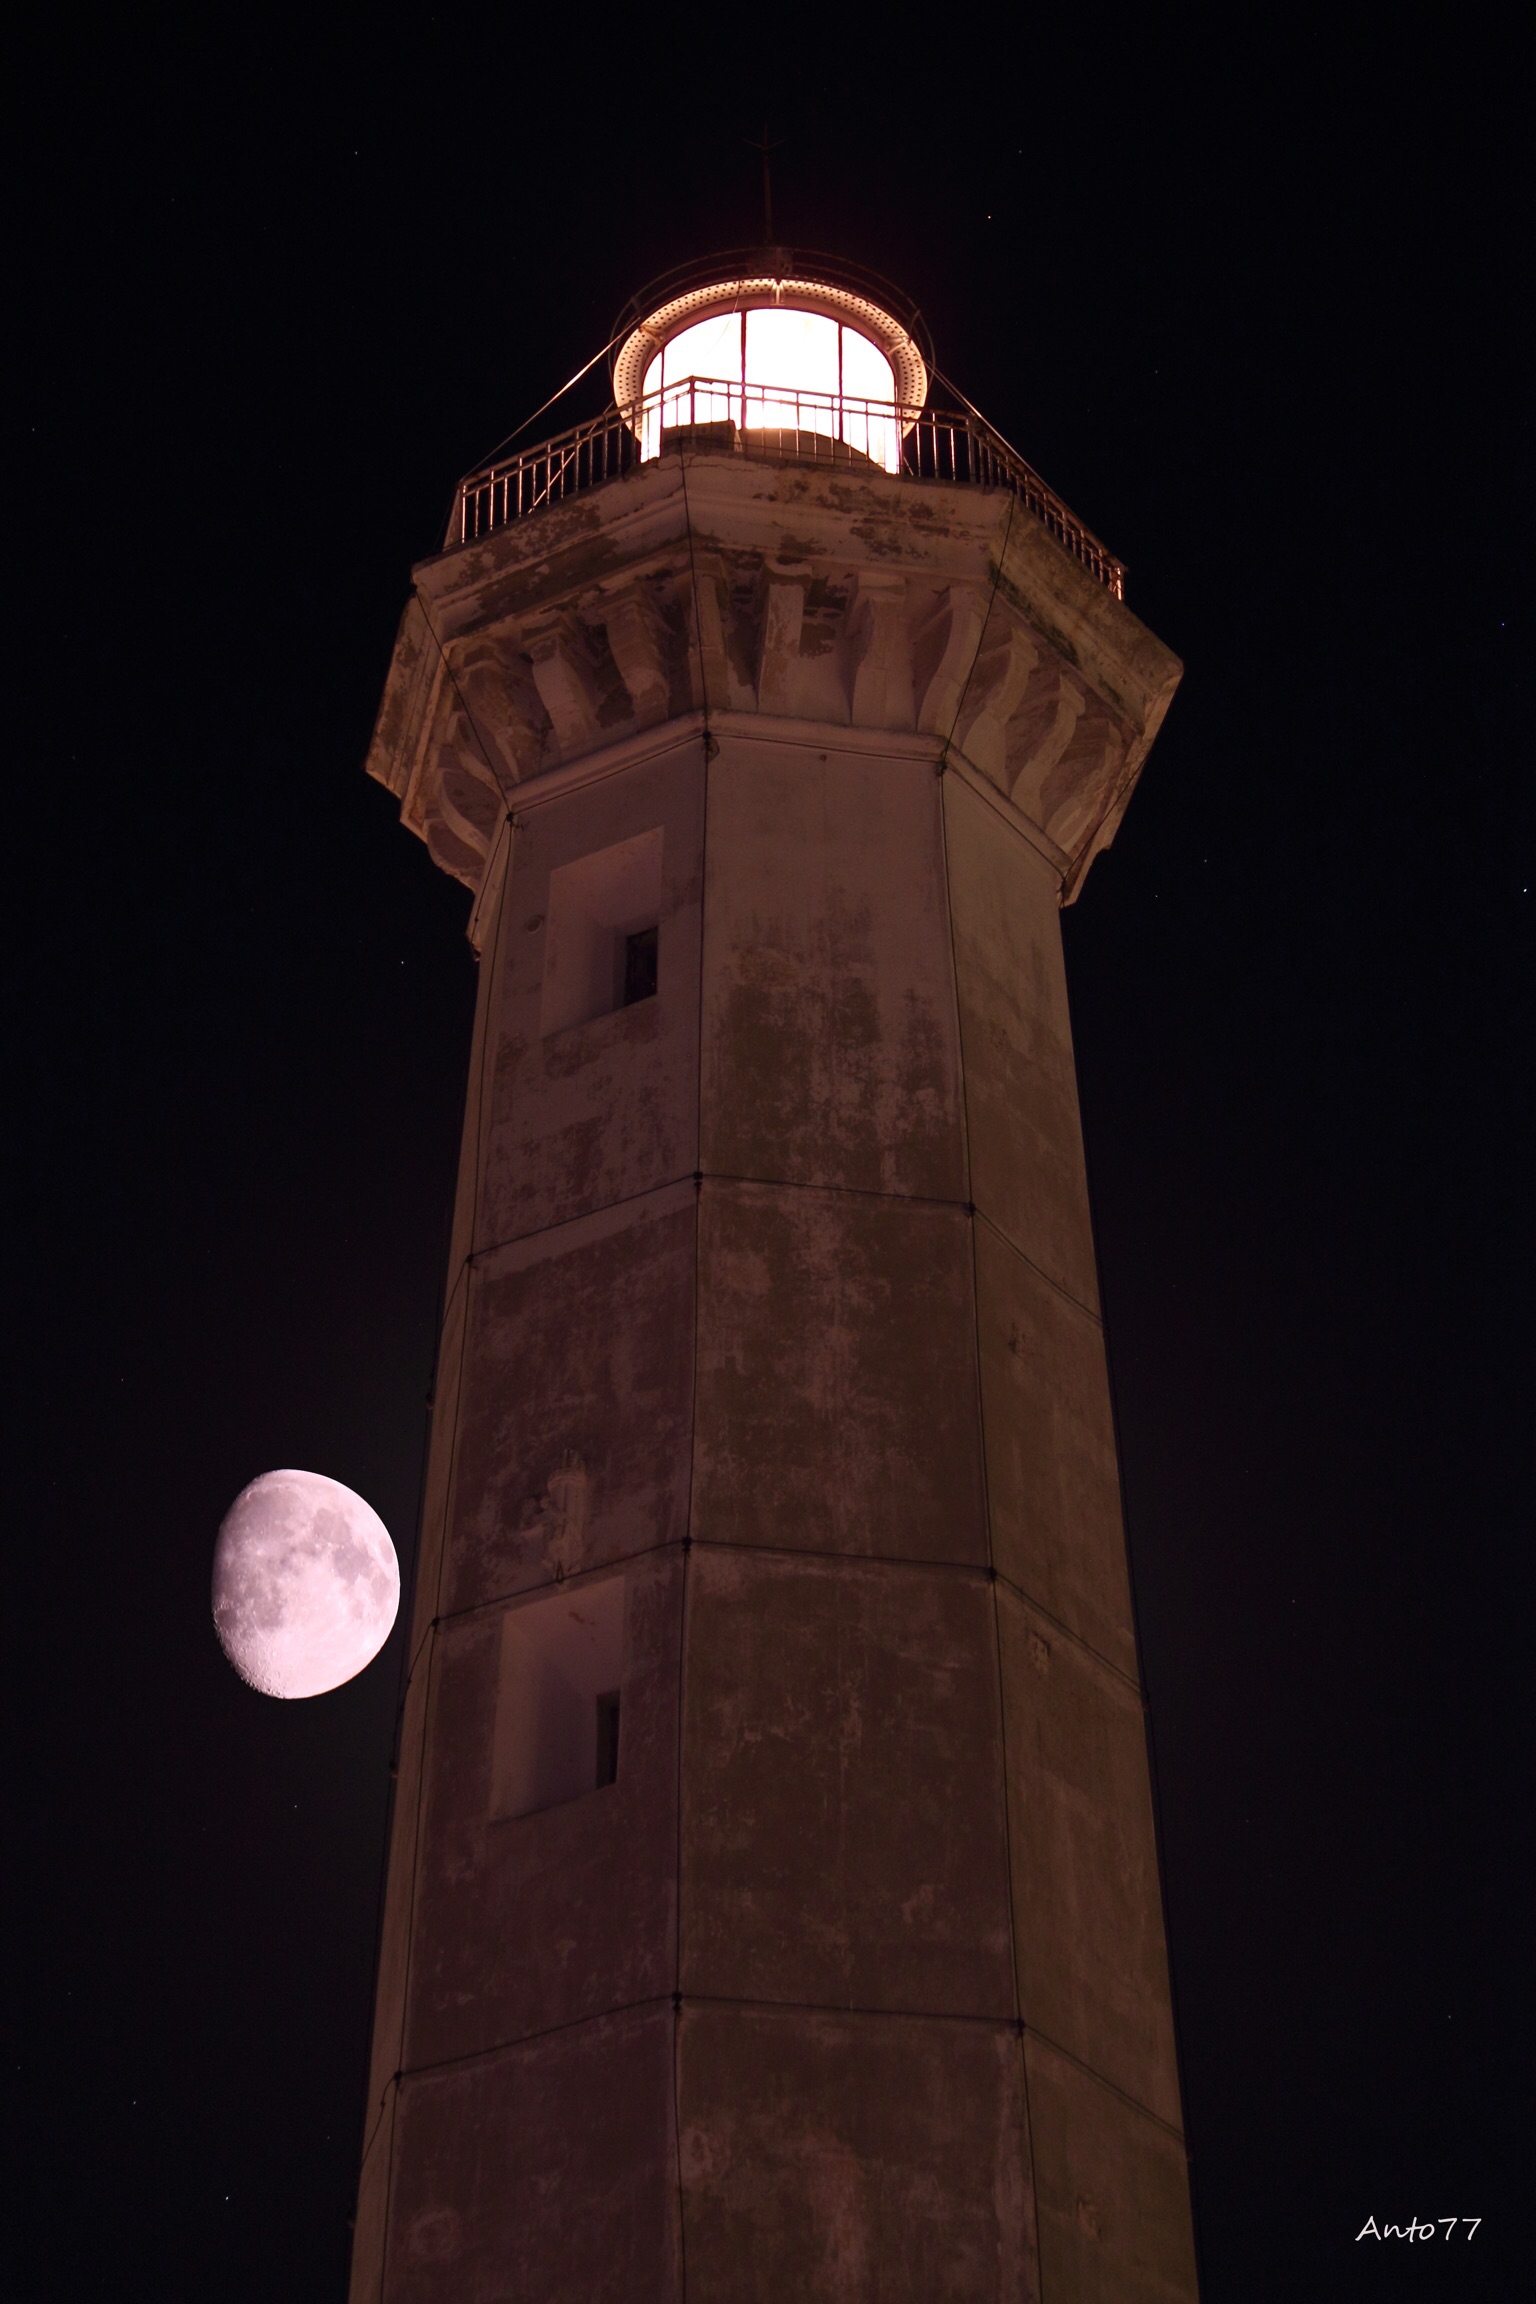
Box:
[444, 251, 1124, 599]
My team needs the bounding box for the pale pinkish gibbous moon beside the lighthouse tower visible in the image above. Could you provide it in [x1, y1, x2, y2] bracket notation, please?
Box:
[214, 1472, 401, 1696]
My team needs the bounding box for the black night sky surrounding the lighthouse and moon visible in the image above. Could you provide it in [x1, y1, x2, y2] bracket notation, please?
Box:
[2, 9, 1536, 2304]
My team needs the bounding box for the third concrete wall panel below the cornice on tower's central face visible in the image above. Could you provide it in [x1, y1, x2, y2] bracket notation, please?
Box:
[682, 1551, 1013, 2018]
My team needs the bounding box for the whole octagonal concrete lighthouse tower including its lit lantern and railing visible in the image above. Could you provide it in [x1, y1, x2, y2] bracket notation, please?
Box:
[352, 249, 1195, 2304]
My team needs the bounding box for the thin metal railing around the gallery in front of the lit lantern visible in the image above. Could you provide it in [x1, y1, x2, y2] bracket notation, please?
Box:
[444, 376, 1126, 599]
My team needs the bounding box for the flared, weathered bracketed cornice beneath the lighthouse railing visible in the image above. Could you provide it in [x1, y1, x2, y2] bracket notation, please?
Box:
[368, 454, 1181, 901]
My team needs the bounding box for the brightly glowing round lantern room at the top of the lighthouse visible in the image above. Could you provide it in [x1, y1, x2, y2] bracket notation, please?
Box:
[613, 249, 928, 472]
